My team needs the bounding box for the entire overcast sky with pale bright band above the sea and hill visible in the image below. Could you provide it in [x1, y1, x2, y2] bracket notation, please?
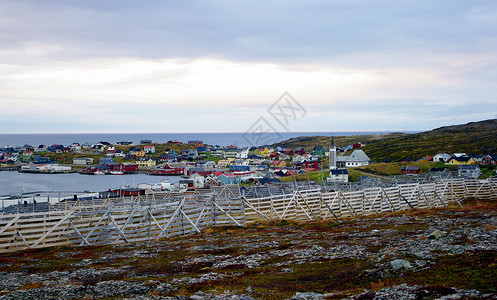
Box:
[0, 0, 497, 133]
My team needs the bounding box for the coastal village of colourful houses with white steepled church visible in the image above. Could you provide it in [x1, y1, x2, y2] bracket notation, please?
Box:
[0, 138, 497, 193]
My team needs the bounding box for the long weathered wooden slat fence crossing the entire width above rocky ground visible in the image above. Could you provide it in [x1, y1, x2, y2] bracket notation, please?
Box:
[0, 179, 497, 252]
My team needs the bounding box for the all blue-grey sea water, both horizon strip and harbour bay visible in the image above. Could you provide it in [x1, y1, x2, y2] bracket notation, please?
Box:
[0, 131, 398, 196]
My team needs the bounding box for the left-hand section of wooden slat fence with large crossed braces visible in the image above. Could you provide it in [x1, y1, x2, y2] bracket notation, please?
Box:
[0, 188, 245, 252]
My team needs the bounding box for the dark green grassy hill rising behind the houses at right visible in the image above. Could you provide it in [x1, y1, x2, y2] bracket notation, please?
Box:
[274, 119, 497, 162]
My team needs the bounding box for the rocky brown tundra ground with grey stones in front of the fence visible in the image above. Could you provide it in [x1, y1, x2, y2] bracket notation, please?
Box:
[0, 199, 497, 299]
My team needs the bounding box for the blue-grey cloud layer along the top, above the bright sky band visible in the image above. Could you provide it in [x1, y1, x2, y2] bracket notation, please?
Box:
[0, 0, 497, 63]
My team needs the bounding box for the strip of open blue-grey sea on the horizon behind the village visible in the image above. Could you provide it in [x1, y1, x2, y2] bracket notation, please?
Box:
[0, 131, 388, 147]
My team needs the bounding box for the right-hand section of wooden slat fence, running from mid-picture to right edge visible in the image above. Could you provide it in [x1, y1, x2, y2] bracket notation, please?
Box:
[243, 179, 497, 223]
